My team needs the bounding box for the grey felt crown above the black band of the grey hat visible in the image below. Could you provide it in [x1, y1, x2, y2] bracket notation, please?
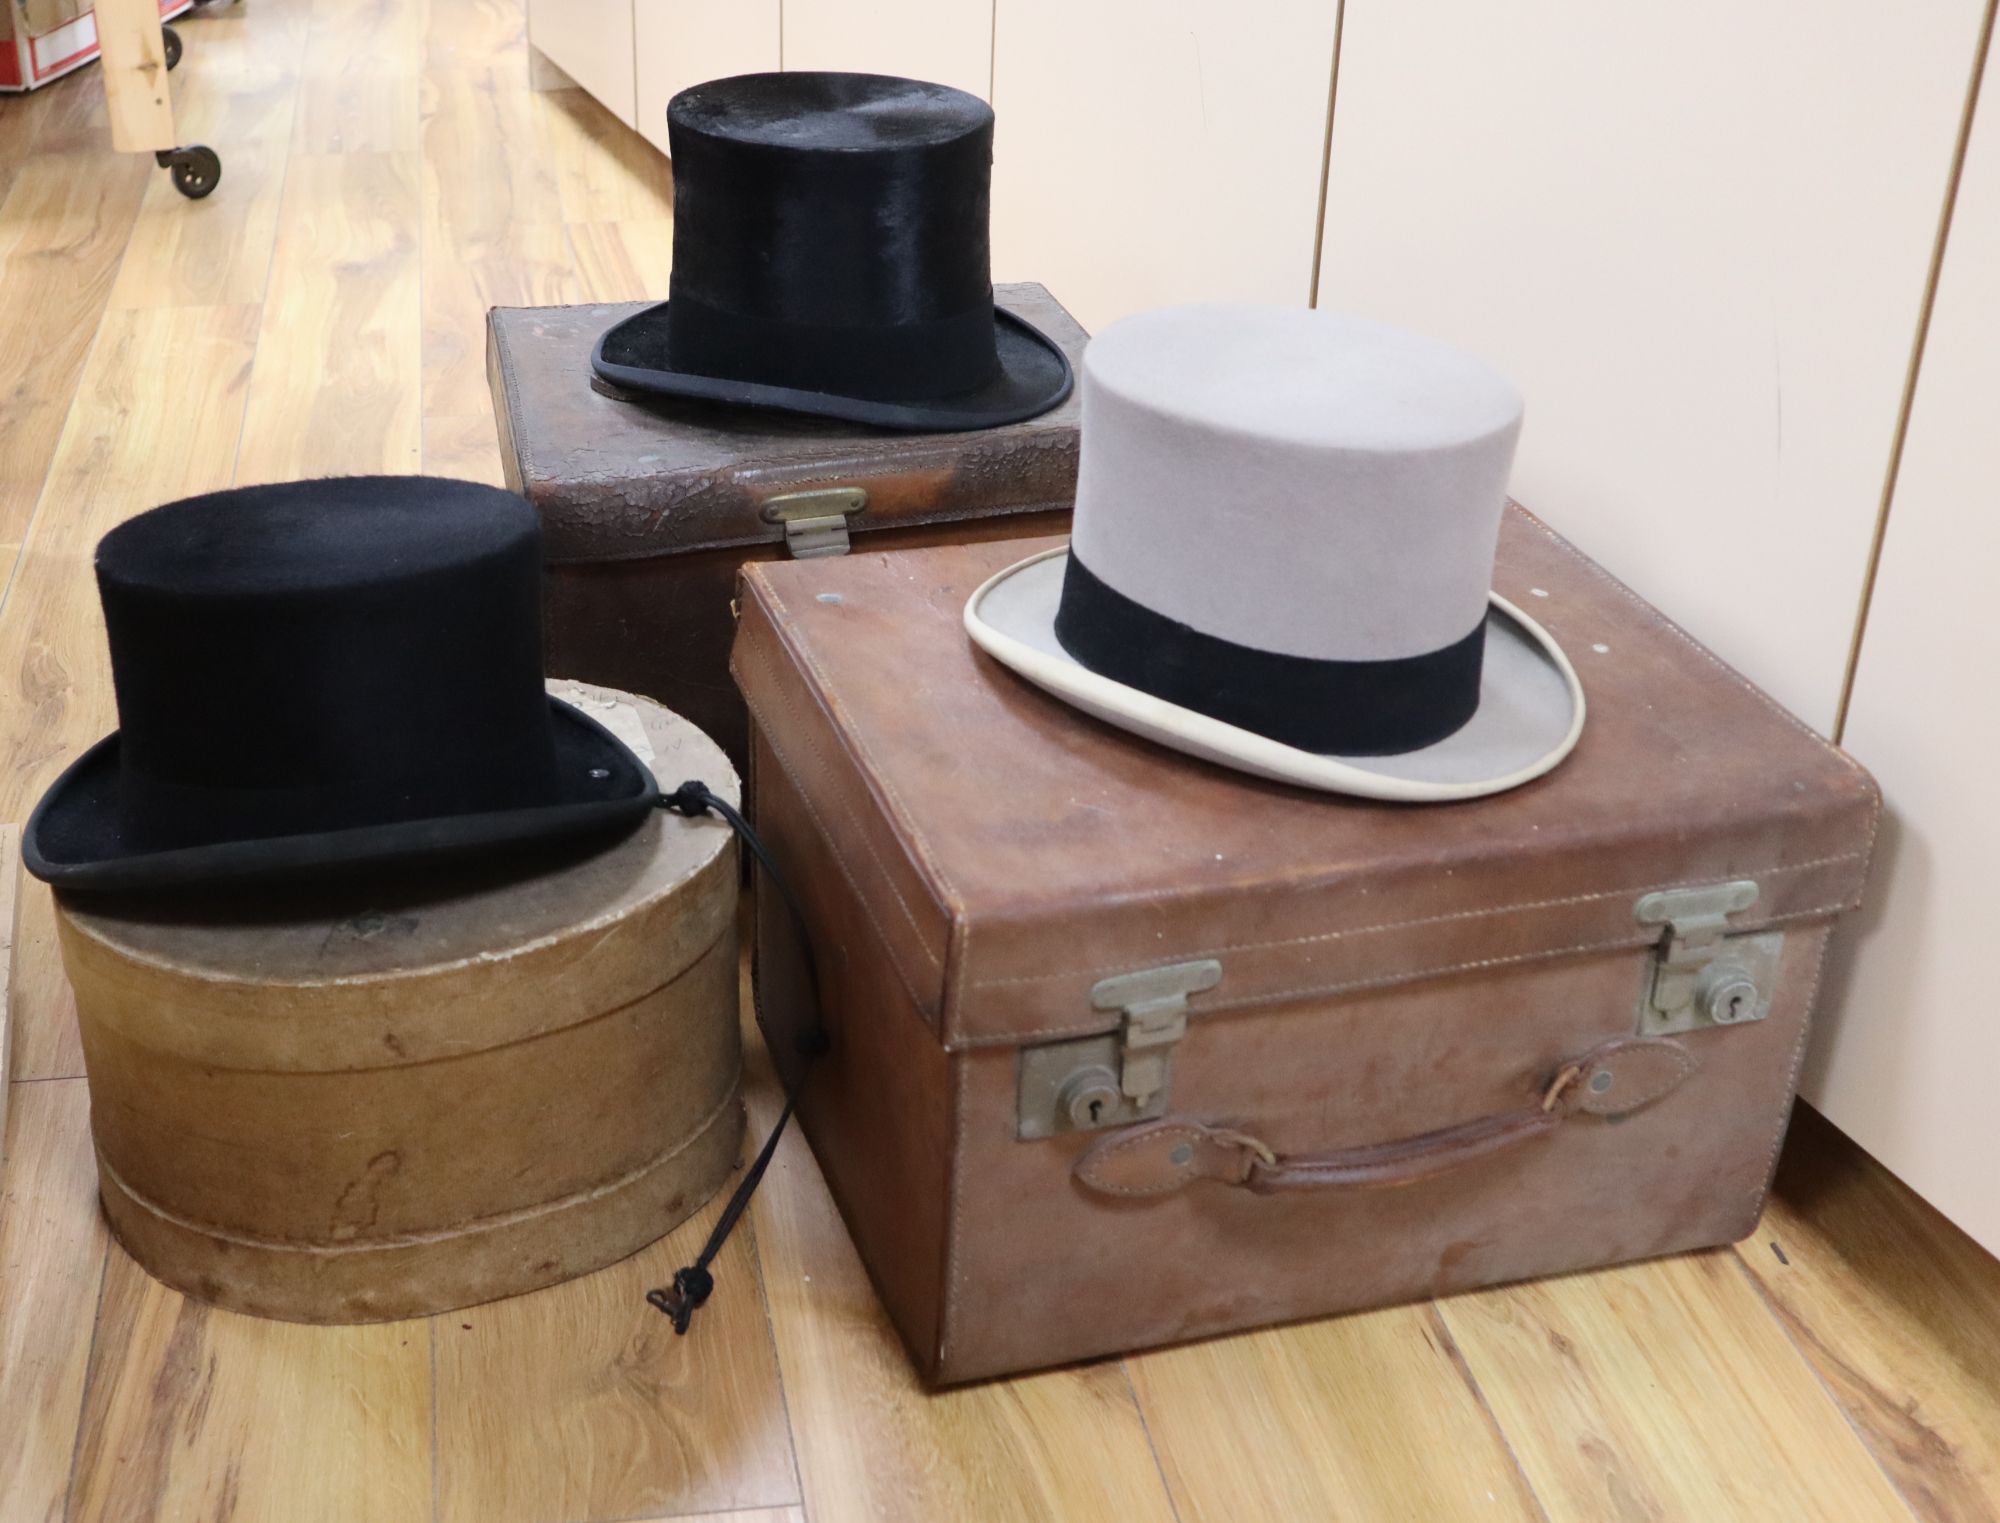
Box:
[1074, 304, 1522, 662]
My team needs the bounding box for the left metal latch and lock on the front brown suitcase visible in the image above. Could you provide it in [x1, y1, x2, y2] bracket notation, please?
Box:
[1014, 957, 1222, 1137]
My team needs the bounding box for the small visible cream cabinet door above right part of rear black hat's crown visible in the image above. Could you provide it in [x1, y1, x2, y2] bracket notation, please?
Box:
[784, 0, 994, 100]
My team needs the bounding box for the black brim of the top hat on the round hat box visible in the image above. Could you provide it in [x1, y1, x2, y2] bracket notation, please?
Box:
[22, 698, 660, 891]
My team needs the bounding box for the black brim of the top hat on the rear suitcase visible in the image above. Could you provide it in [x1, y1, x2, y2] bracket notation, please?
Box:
[590, 302, 1076, 434]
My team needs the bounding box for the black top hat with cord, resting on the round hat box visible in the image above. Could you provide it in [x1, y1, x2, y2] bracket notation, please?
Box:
[22, 476, 658, 889]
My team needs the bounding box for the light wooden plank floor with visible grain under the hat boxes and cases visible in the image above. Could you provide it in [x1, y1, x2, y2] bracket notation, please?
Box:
[0, 0, 2000, 1523]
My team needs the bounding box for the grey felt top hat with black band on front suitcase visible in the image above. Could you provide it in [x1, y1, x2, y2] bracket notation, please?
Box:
[966, 295, 1584, 801]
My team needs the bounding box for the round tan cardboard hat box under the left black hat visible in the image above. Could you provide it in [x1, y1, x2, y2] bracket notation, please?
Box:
[56, 684, 742, 1323]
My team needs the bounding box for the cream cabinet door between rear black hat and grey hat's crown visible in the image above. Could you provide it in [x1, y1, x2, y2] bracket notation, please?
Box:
[988, 0, 1336, 330]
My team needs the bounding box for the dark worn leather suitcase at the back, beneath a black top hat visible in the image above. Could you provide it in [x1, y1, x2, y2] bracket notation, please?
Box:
[486, 286, 1086, 767]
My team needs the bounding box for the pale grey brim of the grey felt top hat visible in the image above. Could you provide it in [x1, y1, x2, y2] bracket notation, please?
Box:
[964, 548, 1584, 803]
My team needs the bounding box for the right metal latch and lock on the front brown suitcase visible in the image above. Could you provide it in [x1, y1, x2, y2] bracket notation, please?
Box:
[1632, 879, 1784, 1035]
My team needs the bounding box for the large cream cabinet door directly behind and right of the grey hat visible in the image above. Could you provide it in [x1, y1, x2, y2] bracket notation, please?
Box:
[1312, 0, 1980, 731]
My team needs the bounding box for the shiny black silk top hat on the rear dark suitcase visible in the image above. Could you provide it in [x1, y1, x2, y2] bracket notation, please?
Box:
[592, 72, 1070, 432]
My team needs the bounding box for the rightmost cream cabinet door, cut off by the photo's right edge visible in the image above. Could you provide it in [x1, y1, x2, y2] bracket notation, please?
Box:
[1806, 11, 2000, 1253]
